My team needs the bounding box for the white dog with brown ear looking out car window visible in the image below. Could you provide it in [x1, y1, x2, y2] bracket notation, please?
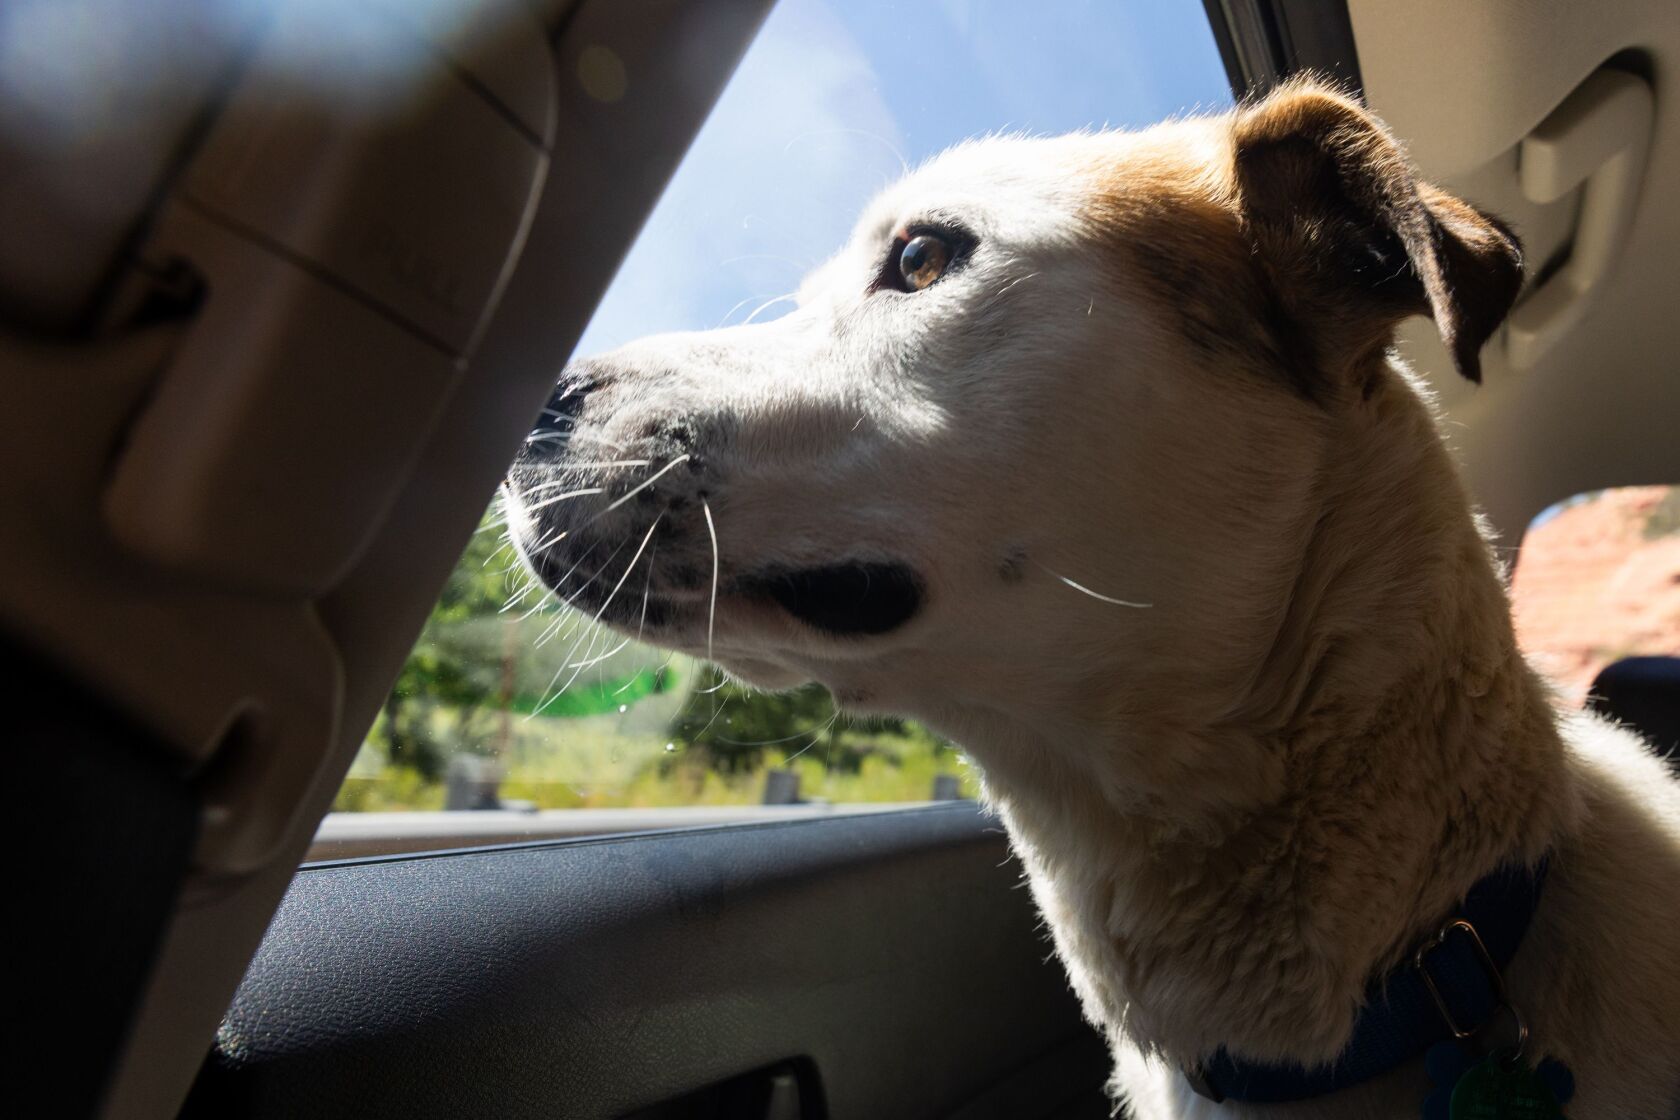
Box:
[506, 79, 1680, 1120]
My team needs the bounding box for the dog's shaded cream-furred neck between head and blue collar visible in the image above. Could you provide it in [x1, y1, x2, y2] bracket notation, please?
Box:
[966, 366, 1569, 1063]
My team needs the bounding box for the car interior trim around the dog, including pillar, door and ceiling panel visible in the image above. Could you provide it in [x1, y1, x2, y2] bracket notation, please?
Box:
[0, 0, 1680, 1120]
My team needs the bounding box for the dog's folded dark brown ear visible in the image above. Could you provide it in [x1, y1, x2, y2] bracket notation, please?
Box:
[1233, 79, 1522, 381]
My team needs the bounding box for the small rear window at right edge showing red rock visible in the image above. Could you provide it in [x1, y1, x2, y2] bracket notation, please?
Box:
[1510, 485, 1680, 704]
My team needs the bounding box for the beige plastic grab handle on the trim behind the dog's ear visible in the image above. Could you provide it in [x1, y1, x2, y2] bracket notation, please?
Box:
[1505, 71, 1653, 369]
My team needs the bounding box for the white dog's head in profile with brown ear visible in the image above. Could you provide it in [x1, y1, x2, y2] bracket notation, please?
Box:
[507, 82, 1520, 745]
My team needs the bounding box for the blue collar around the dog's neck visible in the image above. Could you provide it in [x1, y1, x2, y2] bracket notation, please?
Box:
[1184, 861, 1546, 1103]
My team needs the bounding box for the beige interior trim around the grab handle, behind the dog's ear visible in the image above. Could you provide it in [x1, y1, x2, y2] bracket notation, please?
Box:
[1347, 0, 1680, 546]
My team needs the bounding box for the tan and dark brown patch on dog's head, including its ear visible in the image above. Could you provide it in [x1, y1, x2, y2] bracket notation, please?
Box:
[1089, 79, 1522, 401]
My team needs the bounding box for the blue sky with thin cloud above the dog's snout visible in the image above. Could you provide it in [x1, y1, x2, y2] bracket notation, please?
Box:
[578, 0, 1231, 354]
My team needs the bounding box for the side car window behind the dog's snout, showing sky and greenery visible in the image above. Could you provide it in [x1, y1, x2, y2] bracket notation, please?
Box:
[312, 0, 1230, 856]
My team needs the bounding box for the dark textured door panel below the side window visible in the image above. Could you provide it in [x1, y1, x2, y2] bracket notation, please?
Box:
[185, 804, 1107, 1120]
